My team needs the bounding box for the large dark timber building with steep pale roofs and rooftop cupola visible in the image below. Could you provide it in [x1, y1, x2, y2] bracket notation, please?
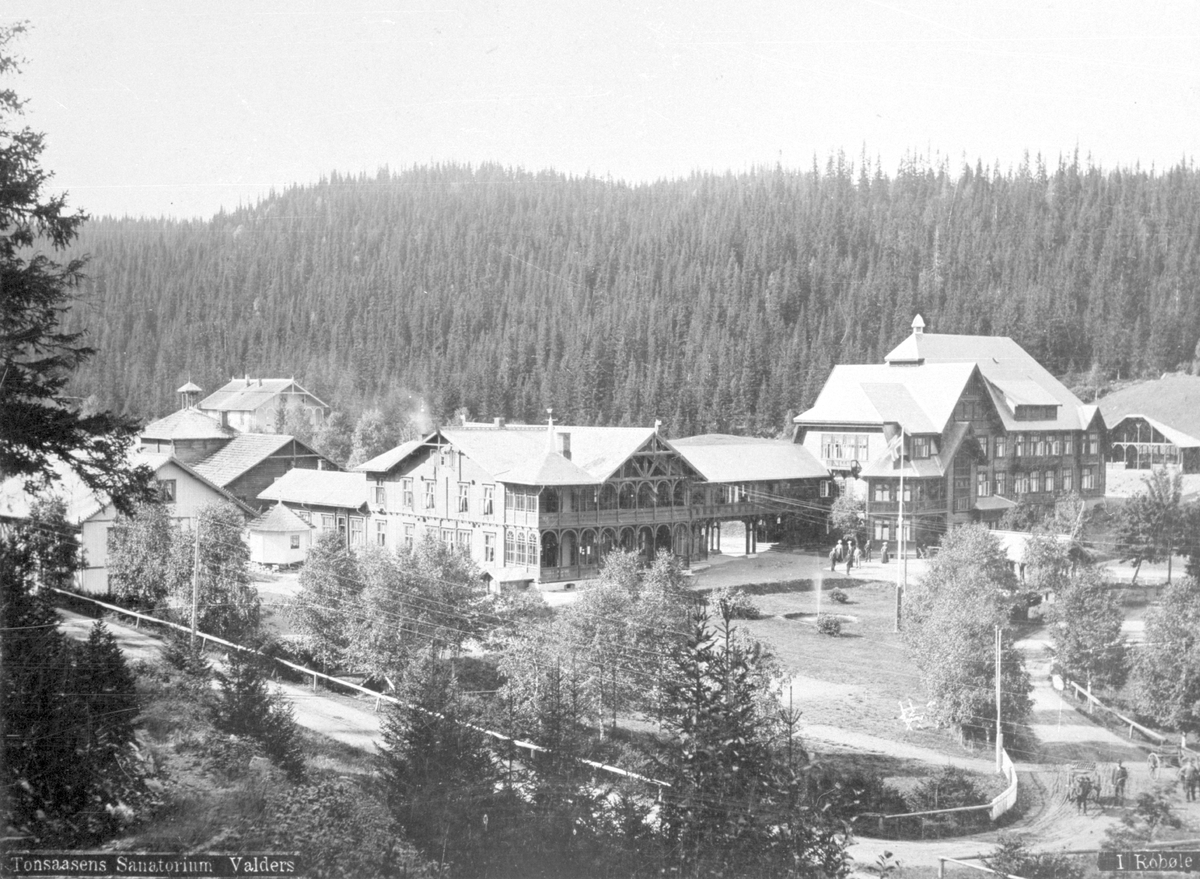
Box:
[796, 316, 1106, 544]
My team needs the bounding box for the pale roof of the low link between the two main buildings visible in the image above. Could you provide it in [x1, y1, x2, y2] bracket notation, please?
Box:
[671, 433, 829, 483]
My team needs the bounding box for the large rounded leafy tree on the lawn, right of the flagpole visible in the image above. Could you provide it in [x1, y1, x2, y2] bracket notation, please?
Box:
[904, 525, 1032, 735]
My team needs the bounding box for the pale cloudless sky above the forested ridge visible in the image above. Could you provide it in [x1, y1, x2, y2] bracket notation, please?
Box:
[0, 0, 1200, 217]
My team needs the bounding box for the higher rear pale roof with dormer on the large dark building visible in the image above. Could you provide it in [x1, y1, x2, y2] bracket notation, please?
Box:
[883, 331, 1091, 430]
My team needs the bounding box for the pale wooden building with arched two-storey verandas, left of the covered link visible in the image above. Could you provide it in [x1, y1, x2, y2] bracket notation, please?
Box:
[356, 419, 828, 588]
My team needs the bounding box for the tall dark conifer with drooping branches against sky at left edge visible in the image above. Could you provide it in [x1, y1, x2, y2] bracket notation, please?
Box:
[0, 24, 151, 509]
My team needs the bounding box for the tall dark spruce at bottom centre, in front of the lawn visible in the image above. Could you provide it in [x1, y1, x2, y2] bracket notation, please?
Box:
[661, 608, 848, 877]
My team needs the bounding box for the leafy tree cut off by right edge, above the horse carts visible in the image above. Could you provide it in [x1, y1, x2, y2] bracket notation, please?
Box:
[1133, 579, 1200, 729]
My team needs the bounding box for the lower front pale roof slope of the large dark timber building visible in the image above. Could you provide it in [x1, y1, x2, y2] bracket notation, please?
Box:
[796, 363, 976, 433]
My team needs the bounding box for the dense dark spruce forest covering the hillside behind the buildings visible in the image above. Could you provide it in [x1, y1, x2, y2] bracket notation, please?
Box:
[67, 156, 1200, 435]
